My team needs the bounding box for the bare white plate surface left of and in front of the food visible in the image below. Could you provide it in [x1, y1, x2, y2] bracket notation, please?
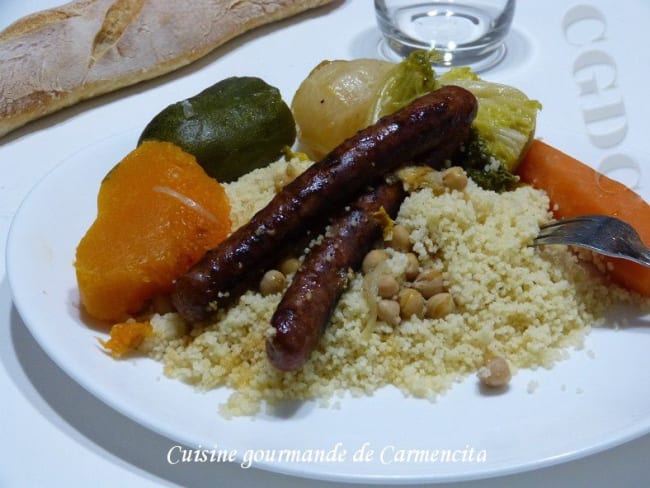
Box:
[7, 132, 650, 483]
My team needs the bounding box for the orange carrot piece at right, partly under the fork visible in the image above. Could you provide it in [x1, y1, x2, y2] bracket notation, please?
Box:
[517, 140, 650, 296]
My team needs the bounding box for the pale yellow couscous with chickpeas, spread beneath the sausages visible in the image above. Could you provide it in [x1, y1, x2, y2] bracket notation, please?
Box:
[139, 158, 646, 416]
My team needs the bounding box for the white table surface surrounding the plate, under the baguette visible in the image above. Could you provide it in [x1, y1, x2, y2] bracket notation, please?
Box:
[0, 0, 650, 488]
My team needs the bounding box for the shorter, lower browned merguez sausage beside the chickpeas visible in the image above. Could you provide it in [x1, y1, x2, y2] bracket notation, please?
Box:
[266, 182, 406, 371]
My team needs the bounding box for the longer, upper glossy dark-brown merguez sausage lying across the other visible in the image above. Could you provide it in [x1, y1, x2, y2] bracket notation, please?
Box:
[172, 86, 477, 322]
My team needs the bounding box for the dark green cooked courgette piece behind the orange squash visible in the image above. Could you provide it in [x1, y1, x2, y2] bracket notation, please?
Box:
[139, 77, 296, 183]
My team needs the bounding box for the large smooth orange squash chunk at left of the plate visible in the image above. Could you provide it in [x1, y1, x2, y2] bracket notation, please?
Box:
[75, 141, 231, 322]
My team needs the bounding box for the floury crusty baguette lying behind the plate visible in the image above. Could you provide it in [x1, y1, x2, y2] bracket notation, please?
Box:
[0, 0, 333, 137]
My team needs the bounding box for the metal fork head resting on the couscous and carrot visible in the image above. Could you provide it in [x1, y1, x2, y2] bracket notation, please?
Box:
[533, 215, 650, 267]
